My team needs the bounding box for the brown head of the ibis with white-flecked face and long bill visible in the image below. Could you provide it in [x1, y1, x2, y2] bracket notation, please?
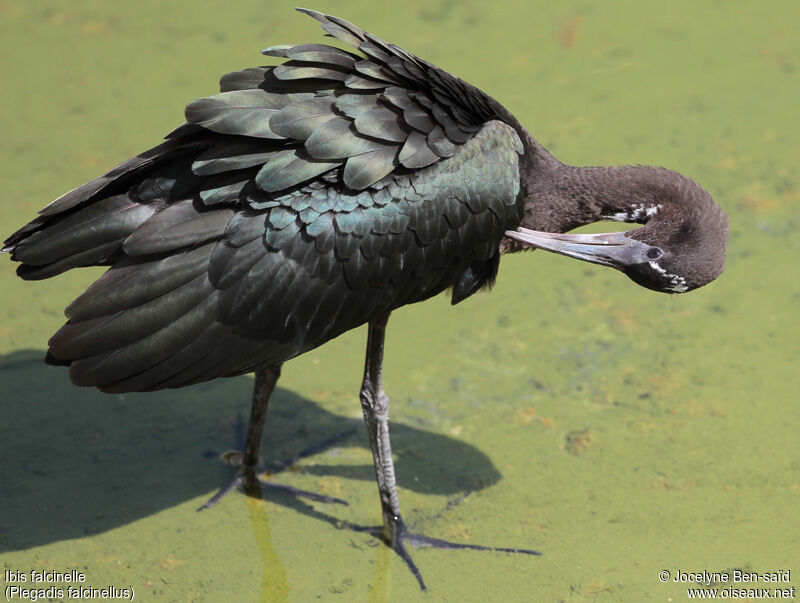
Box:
[506, 168, 728, 293]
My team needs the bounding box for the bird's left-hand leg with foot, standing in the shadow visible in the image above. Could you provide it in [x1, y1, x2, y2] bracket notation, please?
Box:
[197, 364, 349, 511]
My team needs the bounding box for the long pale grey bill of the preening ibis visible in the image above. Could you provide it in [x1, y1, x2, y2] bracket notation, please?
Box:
[506, 227, 650, 270]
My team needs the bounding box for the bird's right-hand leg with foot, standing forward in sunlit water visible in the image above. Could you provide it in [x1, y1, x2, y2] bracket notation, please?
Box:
[360, 314, 540, 591]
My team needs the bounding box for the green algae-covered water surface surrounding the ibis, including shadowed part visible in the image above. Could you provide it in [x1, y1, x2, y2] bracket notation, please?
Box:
[0, 0, 800, 601]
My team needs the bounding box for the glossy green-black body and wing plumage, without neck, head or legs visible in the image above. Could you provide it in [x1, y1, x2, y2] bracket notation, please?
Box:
[6, 11, 523, 391]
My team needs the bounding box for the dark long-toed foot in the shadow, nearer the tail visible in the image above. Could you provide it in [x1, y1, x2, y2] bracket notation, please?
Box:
[197, 430, 355, 511]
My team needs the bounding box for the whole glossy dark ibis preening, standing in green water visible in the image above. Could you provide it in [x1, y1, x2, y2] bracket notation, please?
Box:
[4, 9, 728, 588]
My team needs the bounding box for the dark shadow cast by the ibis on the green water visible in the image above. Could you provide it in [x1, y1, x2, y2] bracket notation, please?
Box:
[0, 350, 500, 552]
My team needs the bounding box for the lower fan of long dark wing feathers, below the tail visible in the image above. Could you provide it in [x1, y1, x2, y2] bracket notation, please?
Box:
[47, 240, 284, 393]
